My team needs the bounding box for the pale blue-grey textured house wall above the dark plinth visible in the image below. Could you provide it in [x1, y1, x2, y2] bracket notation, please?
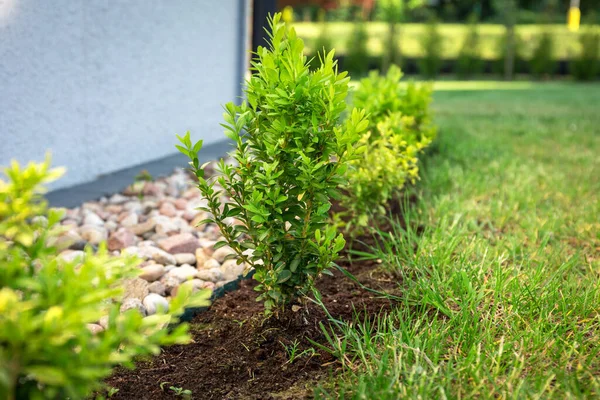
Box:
[0, 0, 245, 188]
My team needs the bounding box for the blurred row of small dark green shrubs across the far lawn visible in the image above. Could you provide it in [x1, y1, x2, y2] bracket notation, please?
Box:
[312, 21, 600, 81]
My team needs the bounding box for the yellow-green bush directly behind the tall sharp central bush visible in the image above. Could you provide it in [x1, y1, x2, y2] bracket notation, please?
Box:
[337, 66, 436, 228]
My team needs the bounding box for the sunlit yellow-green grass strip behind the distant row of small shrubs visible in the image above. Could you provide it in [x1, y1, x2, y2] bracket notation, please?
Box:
[294, 22, 596, 59]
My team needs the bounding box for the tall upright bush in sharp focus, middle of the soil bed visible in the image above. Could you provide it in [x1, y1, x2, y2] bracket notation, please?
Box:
[178, 14, 368, 313]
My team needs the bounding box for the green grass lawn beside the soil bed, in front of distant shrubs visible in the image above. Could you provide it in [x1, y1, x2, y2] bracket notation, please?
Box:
[318, 82, 600, 399]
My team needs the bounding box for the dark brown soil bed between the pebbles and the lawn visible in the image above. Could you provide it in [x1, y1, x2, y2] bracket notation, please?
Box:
[106, 253, 397, 399]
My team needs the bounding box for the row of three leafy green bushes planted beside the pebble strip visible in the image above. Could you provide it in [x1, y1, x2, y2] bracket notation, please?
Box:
[0, 10, 436, 399]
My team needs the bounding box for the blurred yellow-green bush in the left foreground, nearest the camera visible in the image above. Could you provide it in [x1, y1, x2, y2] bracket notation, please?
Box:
[0, 156, 210, 399]
